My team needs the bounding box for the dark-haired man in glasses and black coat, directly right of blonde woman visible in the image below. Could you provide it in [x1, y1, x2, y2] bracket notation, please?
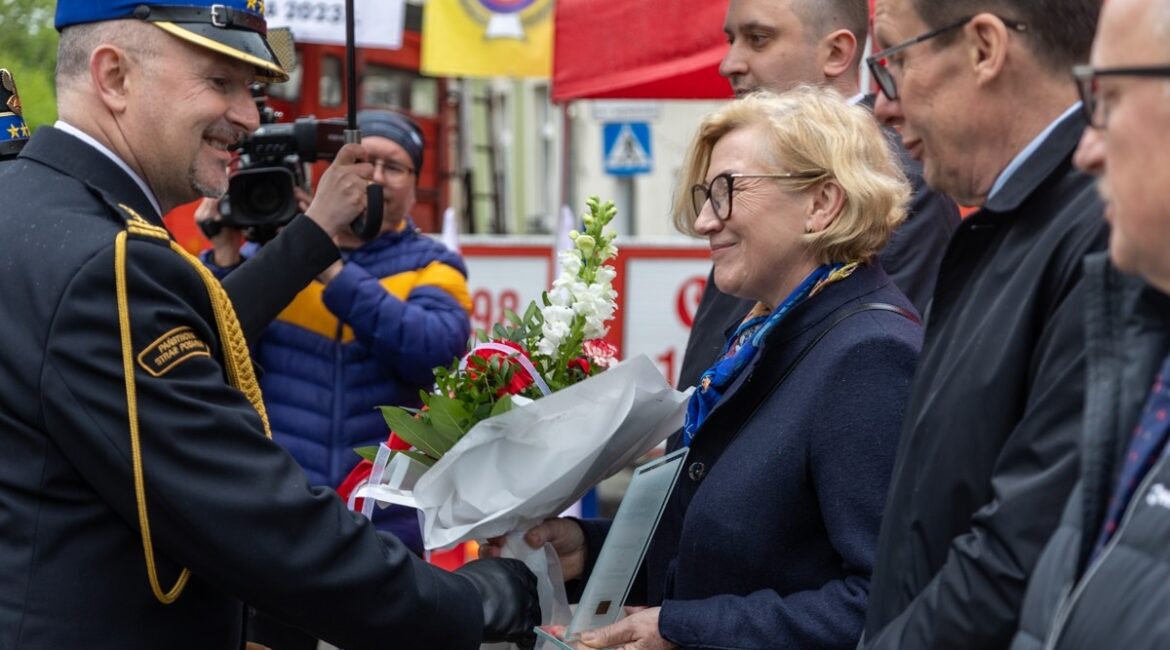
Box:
[863, 0, 1107, 650]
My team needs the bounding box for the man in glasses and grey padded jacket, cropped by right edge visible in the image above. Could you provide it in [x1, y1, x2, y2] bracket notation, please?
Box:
[1012, 0, 1170, 650]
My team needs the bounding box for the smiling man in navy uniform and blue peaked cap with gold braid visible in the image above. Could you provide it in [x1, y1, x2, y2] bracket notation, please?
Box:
[0, 0, 539, 650]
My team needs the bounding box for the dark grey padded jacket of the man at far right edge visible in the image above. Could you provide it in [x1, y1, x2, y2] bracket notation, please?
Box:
[1012, 254, 1170, 650]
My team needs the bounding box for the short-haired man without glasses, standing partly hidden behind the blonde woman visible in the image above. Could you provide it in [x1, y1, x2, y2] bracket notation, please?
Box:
[679, 0, 959, 386]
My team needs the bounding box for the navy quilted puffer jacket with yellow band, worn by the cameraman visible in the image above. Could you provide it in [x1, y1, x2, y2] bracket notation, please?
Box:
[205, 222, 470, 488]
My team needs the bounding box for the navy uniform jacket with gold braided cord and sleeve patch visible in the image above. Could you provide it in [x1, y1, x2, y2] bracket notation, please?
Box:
[0, 129, 482, 650]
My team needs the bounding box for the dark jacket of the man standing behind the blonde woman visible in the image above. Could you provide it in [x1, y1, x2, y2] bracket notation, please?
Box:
[679, 96, 959, 387]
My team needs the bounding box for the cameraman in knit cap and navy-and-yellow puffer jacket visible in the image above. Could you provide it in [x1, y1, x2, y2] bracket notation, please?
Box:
[197, 110, 470, 648]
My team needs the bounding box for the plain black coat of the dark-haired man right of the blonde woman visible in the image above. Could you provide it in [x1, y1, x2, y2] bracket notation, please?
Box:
[866, 111, 1108, 650]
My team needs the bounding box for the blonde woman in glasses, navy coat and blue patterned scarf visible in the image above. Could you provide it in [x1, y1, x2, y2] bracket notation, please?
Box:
[487, 88, 921, 649]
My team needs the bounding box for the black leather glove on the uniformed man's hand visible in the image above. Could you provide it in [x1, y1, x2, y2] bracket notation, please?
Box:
[455, 558, 541, 648]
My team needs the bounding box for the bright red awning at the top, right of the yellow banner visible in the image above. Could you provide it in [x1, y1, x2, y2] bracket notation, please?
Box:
[552, 0, 731, 102]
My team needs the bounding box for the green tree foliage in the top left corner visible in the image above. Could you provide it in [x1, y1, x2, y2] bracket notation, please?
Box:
[0, 0, 57, 130]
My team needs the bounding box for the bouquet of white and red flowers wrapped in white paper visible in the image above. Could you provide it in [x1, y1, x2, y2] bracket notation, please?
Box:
[338, 198, 687, 549]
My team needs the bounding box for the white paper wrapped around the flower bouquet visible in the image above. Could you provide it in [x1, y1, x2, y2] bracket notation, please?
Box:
[355, 355, 689, 645]
